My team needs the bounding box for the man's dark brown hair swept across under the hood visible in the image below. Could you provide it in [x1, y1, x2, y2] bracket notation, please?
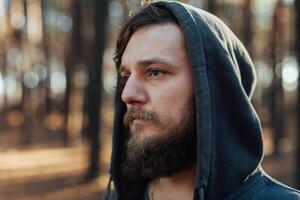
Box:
[114, 4, 178, 69]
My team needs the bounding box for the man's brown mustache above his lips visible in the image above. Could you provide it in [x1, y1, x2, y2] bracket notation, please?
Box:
[123, 108, 161, 127]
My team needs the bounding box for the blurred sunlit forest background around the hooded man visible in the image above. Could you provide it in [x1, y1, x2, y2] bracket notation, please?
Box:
[0, 0, 300, 200]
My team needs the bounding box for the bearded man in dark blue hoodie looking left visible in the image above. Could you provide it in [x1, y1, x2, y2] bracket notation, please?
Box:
[103, 1, 300, 200]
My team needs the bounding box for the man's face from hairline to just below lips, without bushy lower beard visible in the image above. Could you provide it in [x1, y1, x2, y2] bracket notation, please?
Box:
[120, 23, 194, 141]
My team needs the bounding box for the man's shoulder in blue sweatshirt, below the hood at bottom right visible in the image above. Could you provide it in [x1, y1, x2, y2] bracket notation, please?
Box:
[253, 176, 300, 200]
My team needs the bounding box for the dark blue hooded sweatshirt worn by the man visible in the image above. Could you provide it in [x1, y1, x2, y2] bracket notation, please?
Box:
[103, 1, 300, 200]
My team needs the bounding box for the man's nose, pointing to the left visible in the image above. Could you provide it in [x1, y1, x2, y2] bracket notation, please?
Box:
[121, 75, 147, 105]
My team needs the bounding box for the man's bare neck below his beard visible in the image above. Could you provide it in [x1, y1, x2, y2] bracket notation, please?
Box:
[148, 166, 196, 200]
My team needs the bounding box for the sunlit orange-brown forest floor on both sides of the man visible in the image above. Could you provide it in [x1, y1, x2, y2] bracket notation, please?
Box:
[0, 136, 295, 200]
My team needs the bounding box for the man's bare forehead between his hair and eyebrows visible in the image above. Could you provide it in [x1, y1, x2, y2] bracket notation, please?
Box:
[122, 23, 186, 65]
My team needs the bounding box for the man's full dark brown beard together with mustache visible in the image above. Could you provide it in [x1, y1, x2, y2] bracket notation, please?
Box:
[122, 109, 197, 179]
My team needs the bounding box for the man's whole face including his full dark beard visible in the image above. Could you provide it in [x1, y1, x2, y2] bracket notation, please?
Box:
[120, 24, 197, 179]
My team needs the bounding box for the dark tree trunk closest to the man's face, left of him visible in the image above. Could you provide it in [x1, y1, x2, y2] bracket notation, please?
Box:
[87, 0, 108, 180]
